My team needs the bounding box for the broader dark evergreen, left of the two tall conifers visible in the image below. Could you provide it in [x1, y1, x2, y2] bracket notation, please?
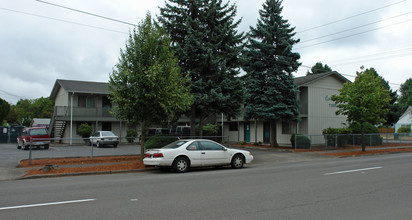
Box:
[159, 0, 244, 135]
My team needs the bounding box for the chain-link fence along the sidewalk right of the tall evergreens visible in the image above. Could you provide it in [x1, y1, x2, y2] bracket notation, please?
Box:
[294, 133, 412, 150]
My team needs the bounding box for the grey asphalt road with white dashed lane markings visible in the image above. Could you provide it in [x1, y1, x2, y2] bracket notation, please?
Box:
[0, 153, 412, 219]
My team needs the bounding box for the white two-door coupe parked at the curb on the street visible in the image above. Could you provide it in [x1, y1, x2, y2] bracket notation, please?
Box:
[143, 139, 253, 173]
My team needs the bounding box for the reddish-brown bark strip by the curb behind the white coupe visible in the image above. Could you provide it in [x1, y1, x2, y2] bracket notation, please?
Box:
[20, 156, 145, 177]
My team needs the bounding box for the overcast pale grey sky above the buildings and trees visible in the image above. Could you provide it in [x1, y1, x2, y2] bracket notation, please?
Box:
[0, 0, 412, 104]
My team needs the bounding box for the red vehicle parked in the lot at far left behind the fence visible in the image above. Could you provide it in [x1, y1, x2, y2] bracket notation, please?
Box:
[17, 127, 50, 150]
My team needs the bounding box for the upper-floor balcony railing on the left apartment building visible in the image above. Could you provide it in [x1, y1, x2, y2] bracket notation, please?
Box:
[54, 106, 113, 118]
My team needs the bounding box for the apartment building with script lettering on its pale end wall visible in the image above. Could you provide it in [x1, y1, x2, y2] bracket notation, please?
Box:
[223, 72, 350, 145]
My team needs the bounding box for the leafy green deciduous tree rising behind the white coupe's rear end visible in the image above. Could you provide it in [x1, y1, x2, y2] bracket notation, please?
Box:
[109, 14, 192, 153]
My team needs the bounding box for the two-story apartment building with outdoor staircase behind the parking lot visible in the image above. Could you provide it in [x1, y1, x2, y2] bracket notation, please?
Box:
[49, 79, 128, 143]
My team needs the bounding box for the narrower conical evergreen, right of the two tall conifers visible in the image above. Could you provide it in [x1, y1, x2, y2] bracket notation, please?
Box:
[244, 0, 300, 147]
